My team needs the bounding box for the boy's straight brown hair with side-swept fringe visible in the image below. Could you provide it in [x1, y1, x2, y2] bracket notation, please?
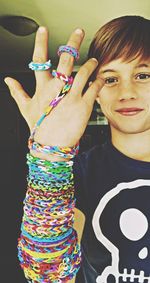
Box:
[88, 16, 150, 79]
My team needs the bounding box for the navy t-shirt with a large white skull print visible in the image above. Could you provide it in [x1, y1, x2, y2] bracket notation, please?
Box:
[74, 142, 150, 283]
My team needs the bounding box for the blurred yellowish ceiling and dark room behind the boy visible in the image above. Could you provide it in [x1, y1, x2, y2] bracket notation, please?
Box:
[0, 0, 150, 283]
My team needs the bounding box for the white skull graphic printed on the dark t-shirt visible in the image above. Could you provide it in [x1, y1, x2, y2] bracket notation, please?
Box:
[92, 179, 150, 283]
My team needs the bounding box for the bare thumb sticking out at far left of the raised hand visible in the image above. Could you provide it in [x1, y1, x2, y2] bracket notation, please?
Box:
[4, 77, 31, 113]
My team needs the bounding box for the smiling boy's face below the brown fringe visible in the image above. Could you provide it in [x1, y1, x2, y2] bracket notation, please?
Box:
[97, 58, 150, 134]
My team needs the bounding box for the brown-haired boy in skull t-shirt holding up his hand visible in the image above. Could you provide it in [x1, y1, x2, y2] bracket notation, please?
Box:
[5, 16, 150, 283]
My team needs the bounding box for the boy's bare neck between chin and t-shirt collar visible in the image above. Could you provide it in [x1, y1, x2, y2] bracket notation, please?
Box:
[112, 131, 150, 162]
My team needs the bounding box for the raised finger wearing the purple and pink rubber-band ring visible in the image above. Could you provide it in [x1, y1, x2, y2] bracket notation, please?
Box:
[57, 28, 84, 76]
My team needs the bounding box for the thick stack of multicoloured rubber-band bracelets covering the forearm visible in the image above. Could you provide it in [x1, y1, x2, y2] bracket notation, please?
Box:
[18, 154, 81, 283]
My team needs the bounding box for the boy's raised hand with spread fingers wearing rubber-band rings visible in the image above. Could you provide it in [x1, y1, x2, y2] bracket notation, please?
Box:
[5, 27, 104, 151]
